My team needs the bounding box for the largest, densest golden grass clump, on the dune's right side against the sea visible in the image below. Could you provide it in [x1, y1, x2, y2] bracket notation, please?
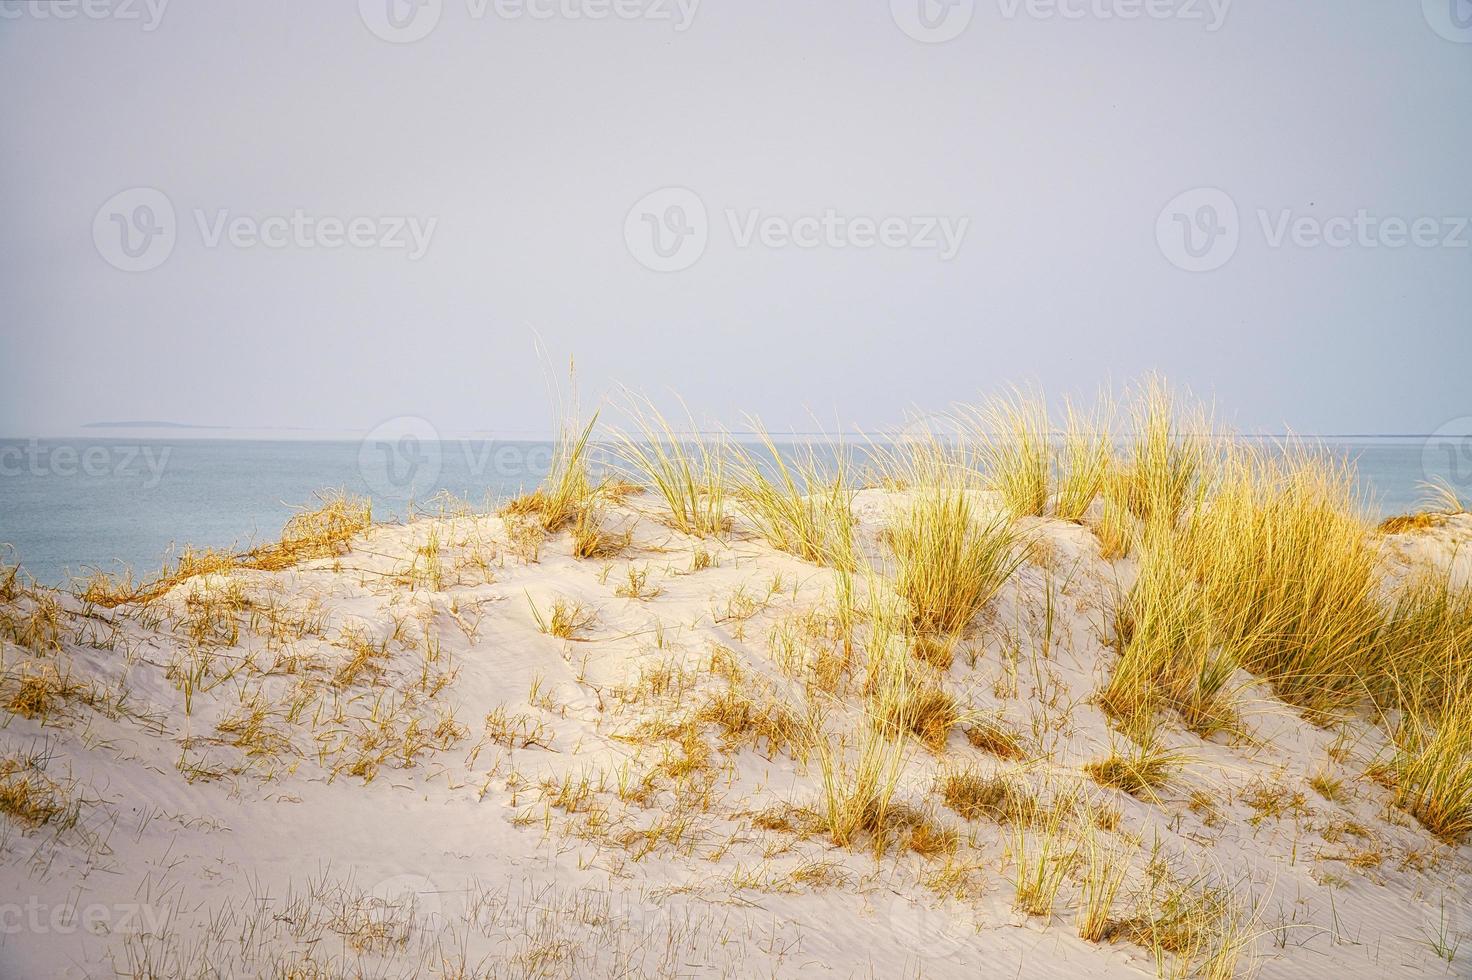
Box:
[1101, 426, 1393, 723]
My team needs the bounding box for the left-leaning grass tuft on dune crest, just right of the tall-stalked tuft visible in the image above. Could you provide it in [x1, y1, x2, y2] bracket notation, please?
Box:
[617, 396, 730, 537]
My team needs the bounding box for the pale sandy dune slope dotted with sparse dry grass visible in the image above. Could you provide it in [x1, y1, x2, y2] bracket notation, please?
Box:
[0, 490, 1472, 977]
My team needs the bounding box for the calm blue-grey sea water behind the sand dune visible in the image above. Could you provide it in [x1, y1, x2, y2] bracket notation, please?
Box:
[0, 437, 1472, 584]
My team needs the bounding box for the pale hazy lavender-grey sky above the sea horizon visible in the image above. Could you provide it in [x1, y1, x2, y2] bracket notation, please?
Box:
[0, 0, 1472, 434]
